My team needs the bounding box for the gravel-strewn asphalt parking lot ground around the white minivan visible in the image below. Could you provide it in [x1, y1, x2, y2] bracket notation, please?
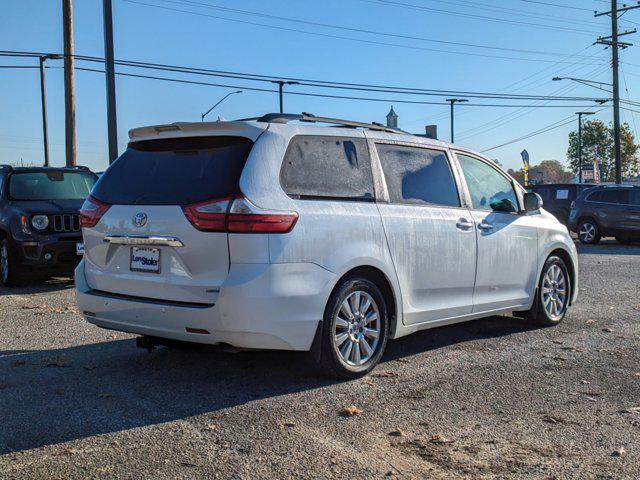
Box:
[0, 242, 640, 479]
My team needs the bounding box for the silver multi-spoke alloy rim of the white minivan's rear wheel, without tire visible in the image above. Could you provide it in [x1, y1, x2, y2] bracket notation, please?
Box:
[333, 290, 382, 367]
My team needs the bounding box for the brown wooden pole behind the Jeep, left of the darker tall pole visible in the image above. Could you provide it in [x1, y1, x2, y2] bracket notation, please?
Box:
[62, 0, 76, 166]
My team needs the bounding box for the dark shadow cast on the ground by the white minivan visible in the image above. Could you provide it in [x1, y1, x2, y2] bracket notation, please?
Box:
[0, 317, 530, 454]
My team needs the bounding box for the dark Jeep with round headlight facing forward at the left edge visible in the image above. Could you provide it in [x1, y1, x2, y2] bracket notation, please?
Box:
[0, 165, 97, 287]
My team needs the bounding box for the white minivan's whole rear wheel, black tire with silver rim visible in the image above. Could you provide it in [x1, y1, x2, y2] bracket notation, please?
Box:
[320, 277, 389, 379]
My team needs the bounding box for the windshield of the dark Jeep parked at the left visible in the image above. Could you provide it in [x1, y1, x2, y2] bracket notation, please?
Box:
[9, 170, 96, 201]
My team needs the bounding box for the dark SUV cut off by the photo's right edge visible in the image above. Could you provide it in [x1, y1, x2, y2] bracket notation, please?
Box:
[569, 185, 640, 244]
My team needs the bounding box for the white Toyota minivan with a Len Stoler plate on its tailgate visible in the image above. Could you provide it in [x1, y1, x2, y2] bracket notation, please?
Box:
[75, 114, 578, 378]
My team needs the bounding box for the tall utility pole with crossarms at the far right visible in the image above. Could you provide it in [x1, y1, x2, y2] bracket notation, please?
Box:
[595, 0, 640, 184]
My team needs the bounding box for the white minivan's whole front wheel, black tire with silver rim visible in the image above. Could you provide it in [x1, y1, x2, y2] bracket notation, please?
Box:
[526, 255, 571, 327]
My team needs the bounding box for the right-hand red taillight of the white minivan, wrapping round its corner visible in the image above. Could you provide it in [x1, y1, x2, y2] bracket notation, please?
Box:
[182, 197, 298, 233]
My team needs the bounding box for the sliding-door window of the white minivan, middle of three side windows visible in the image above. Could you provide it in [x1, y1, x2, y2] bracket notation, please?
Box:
[376, 144, 460, 207]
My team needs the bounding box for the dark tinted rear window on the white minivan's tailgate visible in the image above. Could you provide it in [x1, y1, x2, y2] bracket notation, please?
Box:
[91, 136, 253, 205]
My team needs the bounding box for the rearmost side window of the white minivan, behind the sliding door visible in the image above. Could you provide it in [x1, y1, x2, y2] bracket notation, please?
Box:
[280, 135, 374, 200]
